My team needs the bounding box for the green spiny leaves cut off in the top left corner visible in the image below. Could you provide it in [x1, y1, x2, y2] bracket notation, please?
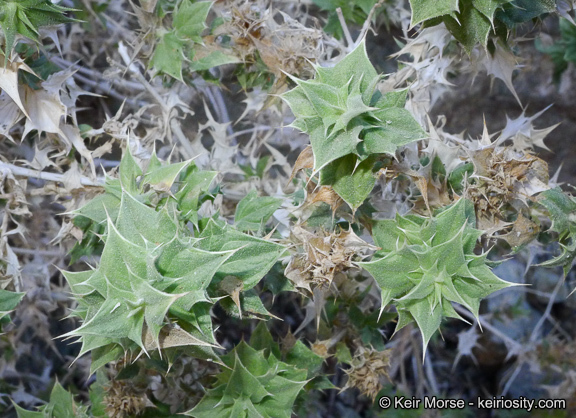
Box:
[0, 0, 75, 59]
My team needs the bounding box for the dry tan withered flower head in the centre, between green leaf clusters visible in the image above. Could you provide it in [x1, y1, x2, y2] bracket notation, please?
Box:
[285, 225, 377, 293]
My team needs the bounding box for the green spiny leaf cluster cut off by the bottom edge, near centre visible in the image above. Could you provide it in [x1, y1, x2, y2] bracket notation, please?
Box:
[186, 338, 313, 418]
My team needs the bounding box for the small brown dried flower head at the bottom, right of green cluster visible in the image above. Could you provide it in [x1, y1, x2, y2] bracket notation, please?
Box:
[342, 346, 392, 400]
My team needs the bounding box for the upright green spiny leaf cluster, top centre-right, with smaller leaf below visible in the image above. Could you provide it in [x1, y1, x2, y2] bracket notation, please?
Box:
[282, 41, 426, 209]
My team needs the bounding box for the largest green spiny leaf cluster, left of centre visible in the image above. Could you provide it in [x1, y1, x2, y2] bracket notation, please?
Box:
[63, 152, 284, 370]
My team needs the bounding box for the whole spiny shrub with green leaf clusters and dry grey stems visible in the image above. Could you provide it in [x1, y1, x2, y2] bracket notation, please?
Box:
[0, 0, 576, 417]
